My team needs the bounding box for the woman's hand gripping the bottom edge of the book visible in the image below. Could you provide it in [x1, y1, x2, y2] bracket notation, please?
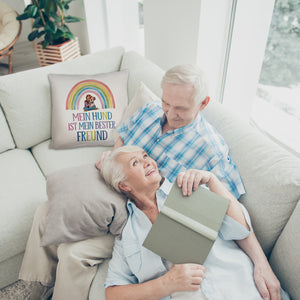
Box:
[161, 264, 205, 295]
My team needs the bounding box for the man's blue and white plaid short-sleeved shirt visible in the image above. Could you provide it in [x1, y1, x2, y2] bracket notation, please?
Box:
[118, 101, 245, 198]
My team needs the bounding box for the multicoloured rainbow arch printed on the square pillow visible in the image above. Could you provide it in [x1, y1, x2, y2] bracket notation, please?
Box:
[66, 79, 116, 110]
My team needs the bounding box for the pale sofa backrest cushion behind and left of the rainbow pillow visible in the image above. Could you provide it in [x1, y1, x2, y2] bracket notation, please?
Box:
[0, 47, 124, 149]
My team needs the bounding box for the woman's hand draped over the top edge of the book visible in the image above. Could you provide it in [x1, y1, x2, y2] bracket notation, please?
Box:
[177, 169, 215, 196]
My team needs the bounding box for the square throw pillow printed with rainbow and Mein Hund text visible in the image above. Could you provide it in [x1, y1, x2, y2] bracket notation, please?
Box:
[48, 70, 128, 149]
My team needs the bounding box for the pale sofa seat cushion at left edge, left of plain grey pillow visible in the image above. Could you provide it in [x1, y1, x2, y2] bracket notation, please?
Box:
[0, 149, 47, 261]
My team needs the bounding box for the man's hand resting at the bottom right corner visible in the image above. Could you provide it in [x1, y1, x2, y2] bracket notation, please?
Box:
[254, 264, 281, 300]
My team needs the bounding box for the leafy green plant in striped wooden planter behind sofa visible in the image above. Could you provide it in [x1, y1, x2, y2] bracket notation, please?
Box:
[17, 0, 82, 66]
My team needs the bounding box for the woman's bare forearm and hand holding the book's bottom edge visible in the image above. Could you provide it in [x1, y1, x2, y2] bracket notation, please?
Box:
[105, 264, 205, 300]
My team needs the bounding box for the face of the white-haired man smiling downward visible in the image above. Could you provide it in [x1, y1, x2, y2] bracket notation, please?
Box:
[162, 83, 201, 129]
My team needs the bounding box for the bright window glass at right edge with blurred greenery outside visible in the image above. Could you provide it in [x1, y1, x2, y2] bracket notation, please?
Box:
[251, 0, 300, 155]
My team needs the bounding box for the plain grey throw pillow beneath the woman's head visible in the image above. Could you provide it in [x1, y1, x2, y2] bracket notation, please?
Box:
[41, 165, 127, 246]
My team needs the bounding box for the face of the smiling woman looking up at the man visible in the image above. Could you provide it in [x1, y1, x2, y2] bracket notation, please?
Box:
[117, 151, 161, 191]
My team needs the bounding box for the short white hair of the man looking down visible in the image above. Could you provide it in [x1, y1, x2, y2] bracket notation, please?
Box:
[161, 64, 208, 104]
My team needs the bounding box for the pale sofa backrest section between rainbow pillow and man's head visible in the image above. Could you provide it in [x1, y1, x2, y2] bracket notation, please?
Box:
[121, 51, 164, 102]
